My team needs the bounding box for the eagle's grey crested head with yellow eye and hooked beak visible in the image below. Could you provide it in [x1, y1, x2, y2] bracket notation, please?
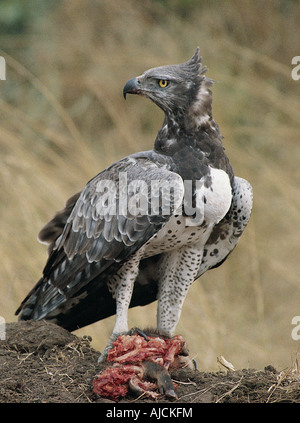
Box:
[123, 48, 213, 130]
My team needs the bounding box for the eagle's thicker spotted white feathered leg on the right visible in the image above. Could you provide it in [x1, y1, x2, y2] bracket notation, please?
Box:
[157, 246, 202, 337]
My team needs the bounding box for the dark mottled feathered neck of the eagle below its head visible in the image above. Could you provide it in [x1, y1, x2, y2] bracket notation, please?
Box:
[154, 80, 232, 179]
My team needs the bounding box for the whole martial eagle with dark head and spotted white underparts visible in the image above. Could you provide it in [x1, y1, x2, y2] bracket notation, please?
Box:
[16, 48, 252, 360]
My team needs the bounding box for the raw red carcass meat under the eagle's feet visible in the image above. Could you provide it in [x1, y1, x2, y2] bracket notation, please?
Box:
[93, 330, 197, 401]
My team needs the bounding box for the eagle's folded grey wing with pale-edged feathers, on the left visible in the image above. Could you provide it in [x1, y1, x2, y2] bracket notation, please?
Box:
[39, 157, 184, 296]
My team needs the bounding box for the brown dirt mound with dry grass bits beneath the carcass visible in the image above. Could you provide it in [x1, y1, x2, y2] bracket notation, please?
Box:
[0, 321, 300, 405]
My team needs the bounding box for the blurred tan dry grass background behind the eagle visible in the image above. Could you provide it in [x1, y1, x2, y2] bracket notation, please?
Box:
[0, 0, 300, 370]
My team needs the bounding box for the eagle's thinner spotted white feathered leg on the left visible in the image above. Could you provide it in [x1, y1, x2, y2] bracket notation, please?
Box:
[98, 251, 142, 363]
